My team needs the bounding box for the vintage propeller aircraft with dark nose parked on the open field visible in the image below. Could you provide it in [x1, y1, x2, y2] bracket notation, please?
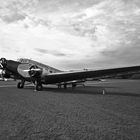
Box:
[0, 58, 140, 91]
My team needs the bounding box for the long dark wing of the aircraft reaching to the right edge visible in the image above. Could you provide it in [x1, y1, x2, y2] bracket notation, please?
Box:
[44, 66, 140, 84]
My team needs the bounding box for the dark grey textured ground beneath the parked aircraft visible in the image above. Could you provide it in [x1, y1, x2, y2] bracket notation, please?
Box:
[0, 80, 140, 140]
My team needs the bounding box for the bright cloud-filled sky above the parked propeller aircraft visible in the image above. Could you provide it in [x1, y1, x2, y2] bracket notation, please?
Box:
[0, 0, 140, 70]
